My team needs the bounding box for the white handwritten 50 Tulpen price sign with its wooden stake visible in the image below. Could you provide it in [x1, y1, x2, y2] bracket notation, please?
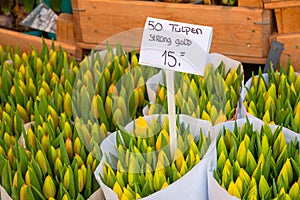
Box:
[139, 17, 212, 158]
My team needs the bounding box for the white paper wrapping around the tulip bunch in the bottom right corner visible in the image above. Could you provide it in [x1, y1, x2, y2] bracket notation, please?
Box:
[207, 116, 300, 200]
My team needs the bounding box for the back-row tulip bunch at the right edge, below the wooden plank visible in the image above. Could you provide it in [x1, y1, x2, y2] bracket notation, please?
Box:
[244, 65, 300, 133]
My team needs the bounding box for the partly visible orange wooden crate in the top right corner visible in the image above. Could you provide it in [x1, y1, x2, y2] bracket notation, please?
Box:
[264, 0, 300, 34]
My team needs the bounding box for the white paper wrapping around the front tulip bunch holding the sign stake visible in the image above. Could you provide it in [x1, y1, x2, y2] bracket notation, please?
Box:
[94, 115, 216, 200]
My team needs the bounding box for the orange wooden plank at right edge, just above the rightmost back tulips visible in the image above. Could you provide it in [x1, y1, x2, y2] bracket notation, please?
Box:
[276, 33, 300, 72]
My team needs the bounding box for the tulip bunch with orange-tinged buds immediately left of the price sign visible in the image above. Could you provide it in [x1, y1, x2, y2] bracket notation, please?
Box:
[72, 45, 156, 132]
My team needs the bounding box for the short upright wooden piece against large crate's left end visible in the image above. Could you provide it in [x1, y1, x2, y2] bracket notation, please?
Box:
[56, 13, 76, 45]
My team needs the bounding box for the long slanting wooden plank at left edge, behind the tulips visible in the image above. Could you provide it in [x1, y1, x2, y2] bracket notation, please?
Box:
[0, 28, 82, 59]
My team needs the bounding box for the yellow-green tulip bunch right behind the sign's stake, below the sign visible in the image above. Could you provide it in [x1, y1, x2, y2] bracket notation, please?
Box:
[149, 62, 243, 124]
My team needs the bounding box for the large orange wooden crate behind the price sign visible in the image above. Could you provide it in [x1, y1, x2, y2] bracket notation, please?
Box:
[72, 0, 274, 64]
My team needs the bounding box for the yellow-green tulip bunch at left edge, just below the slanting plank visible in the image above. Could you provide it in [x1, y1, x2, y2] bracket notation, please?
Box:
[0, 44, 78, 123]
